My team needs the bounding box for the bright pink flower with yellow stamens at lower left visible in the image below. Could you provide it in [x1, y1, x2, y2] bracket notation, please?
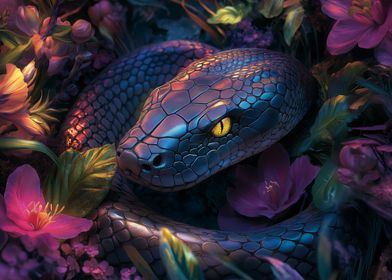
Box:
[0, 165, 92, 239]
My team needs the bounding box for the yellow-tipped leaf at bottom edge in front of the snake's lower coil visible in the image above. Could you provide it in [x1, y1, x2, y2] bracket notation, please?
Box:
[159, 228, 204, 280]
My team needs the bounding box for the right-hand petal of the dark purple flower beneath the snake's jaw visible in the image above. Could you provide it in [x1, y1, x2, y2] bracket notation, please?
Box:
[285, 156, 320, 208]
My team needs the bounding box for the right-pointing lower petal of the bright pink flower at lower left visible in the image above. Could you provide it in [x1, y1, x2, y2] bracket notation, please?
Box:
[42, 215, 93, 239]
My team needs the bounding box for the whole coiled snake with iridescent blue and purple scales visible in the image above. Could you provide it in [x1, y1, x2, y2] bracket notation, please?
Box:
[60, 40, 352, 279]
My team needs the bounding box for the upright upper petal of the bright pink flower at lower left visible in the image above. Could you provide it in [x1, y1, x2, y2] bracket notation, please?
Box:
[4, 164, 45, 230]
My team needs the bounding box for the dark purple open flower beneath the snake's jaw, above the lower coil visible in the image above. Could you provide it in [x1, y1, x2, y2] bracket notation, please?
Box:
[219, 144, 319, 228]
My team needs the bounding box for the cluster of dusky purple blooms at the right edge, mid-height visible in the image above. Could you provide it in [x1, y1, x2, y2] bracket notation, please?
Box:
[337, 125, 392, 221]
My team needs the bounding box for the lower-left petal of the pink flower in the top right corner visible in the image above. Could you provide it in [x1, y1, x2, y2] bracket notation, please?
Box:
[327, 20, 370, 55]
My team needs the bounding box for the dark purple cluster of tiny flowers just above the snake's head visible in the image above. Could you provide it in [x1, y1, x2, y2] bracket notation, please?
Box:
[229, 19, 273, 48]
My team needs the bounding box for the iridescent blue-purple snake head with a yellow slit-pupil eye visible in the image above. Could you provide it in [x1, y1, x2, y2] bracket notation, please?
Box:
[117, 49, 309, 191]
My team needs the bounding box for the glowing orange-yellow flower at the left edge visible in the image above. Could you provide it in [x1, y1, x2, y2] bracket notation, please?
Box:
[0, 64, 44, 134]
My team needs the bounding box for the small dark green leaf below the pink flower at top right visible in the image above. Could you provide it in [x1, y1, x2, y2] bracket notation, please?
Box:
[328, 61, 368, 97]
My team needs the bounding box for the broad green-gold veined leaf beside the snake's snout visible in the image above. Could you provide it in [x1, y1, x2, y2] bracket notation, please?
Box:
[43, 144, 116, 217]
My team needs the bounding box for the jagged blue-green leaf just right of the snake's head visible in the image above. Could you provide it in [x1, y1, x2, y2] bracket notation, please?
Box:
[293, 95, 357, 155]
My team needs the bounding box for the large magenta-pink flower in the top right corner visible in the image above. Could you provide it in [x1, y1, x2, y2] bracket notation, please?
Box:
[322, 0, 392, 65]
